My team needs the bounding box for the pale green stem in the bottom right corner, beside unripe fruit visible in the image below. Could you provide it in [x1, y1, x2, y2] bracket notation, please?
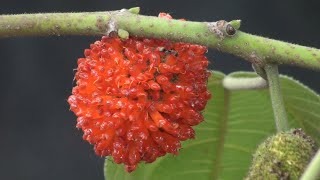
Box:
[300, 149, 320, 180]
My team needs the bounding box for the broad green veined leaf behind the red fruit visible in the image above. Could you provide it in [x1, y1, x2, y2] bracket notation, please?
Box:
[105, 72, 320, 180]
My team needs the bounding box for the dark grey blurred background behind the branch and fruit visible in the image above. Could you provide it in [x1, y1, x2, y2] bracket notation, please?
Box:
[0, 0, 320, 180]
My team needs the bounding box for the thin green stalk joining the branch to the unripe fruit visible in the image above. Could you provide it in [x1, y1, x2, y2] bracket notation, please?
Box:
[265, 64, 289, 132]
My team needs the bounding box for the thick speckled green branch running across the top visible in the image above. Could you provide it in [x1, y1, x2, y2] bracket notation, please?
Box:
[0, 9, 320, 70]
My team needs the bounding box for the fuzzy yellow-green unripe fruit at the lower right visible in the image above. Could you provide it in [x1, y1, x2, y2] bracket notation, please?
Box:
[246, 129, 316, 180]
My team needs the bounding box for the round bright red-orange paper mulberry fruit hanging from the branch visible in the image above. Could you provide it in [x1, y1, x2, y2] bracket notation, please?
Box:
[68, 12, 211, 172]
